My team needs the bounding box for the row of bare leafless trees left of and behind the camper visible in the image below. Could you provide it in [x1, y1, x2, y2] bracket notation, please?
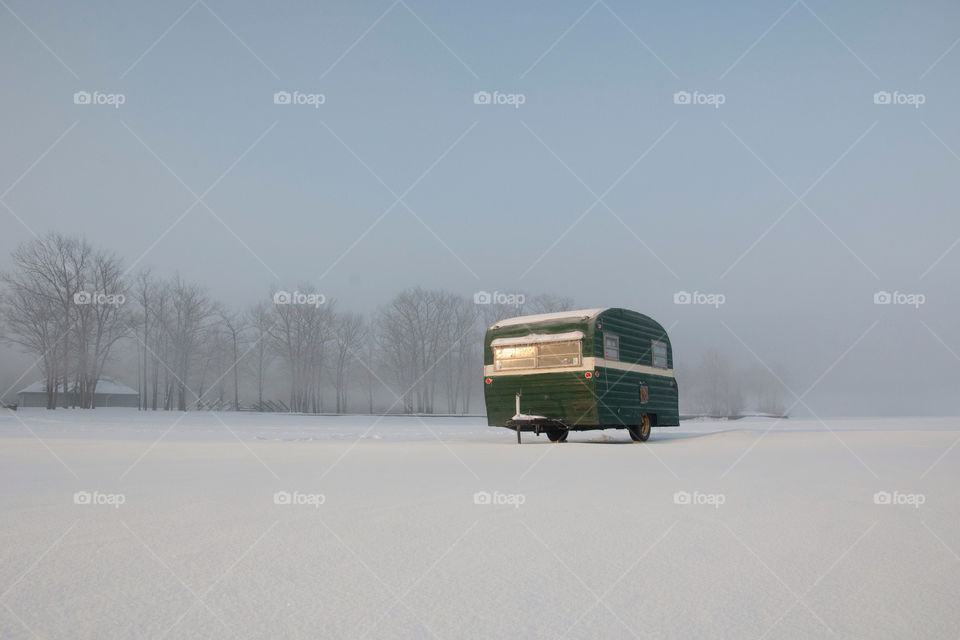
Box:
[0, 233, 573, 413]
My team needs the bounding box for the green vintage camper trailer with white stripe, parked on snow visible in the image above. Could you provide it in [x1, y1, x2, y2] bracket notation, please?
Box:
[483, 308, 680, 443]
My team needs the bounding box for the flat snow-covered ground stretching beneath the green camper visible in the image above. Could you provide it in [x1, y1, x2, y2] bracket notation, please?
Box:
[0, 409, 960, 638]
